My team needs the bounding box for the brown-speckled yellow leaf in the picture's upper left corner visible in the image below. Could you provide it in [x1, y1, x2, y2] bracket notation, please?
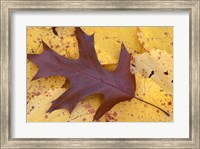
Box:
[27, 27, 79, 59]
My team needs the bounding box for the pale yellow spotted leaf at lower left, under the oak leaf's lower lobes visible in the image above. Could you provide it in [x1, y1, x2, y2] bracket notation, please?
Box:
[27, 88, 100, 122]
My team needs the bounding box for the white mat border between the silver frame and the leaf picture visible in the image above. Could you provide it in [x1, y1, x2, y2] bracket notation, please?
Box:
[11, 11, 189, 138]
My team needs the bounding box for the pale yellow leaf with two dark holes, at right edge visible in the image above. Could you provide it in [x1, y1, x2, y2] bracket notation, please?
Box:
[131, 49, 173, 94]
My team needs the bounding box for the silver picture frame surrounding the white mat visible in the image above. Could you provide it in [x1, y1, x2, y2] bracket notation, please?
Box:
[0, 0, 200, 149]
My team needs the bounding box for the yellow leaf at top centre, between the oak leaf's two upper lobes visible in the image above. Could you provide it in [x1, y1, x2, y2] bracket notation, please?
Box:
[82, 27, 143, 64]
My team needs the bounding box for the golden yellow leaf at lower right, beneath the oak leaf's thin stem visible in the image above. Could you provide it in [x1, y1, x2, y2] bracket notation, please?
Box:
[101, 74, 173, 122]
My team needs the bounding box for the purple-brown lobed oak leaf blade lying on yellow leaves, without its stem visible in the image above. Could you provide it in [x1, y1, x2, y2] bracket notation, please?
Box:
[28, 28, 136, 120]
